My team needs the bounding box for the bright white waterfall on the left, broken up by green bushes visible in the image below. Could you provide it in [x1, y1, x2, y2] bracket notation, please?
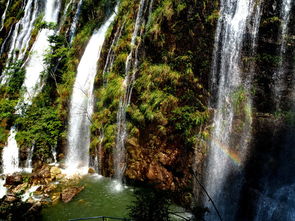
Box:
[2, 0, 60, 174]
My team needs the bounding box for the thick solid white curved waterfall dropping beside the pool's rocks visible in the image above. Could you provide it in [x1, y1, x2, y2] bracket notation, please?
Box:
[66, 9, 115, 175]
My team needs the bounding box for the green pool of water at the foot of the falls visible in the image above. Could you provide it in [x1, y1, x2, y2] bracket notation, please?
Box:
[42, 176, 134, 221]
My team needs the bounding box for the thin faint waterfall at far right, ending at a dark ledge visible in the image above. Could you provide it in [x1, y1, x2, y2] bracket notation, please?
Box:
[274, 0, 292, 110]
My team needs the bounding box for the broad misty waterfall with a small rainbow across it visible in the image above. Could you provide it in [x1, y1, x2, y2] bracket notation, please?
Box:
[204, 0, 260, 220]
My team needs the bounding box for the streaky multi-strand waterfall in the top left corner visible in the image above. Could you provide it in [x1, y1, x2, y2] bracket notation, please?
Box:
[1, 0, 38, 84]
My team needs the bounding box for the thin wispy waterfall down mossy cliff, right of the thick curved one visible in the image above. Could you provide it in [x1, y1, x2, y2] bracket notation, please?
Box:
[113, 0, 152, 182]
